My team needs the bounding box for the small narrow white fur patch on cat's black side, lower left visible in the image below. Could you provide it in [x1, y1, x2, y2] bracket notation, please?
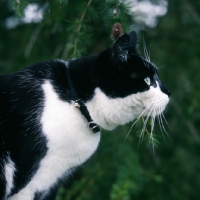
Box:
[5, 158, 15, 195]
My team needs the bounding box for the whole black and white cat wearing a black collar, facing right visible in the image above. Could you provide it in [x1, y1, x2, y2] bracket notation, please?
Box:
[0, 32, 170, 200]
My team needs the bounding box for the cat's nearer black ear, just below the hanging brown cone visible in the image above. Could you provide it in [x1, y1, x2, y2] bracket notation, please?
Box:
[111, 33, 130, 65]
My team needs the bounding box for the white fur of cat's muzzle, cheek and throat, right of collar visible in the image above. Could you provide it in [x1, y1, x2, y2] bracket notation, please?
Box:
[86, 84, 169, 130]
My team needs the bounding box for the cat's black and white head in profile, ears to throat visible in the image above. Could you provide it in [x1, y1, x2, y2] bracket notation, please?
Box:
[88, 32, 170, 129]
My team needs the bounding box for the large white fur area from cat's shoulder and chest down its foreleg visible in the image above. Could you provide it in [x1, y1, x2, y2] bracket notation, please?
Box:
[9, 81, 100, 200]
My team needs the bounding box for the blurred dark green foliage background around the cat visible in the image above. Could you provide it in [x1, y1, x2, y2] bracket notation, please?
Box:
[0, 0, 200, 200]
